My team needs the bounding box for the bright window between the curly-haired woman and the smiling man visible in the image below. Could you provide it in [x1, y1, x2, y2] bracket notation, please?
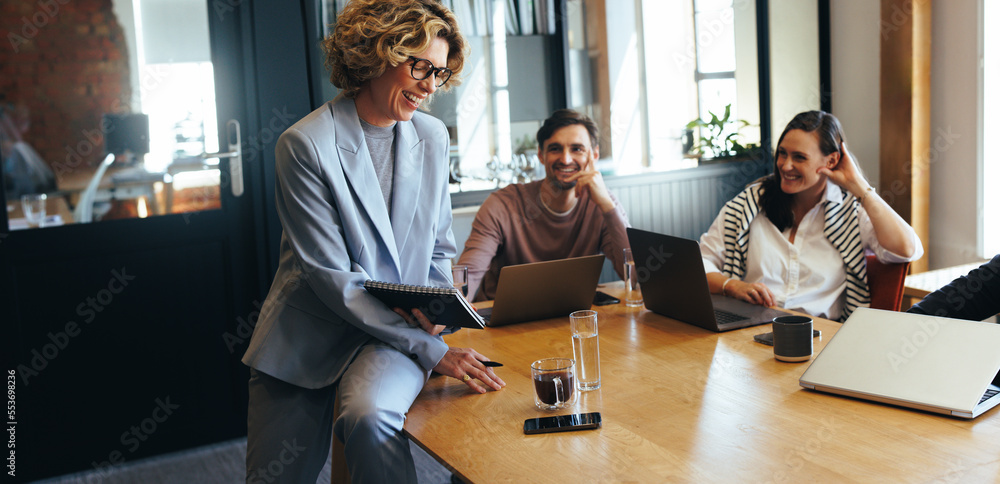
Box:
[428, 0, 564, 191]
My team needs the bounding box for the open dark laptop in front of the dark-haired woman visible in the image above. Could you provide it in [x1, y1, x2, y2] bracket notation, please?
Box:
[626, 228, 788, 331]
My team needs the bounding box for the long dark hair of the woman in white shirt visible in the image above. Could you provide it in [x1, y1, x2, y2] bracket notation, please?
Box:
[760, 111, 844, 231]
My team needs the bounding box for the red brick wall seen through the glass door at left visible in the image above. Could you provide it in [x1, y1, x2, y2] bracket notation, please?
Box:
[0, 0, 131, 176]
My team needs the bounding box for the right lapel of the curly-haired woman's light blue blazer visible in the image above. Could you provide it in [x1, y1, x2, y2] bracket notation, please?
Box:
[392, 121, 426, 253]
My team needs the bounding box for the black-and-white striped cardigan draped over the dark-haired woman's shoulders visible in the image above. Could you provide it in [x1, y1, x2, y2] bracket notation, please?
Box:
[722, 183, 870, 321]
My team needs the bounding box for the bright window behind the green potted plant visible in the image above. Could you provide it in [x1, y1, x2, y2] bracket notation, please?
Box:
[640, 0, 760, 170]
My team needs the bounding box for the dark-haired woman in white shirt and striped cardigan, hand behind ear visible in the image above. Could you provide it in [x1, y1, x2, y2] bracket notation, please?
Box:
[701, 111, 923, 321]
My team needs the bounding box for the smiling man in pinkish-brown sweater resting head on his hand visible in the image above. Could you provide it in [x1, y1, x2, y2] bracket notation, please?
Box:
[458, 109, 628, 301]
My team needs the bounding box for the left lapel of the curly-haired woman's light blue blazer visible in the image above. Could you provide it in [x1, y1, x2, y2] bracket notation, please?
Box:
[333, 99, 402, 279]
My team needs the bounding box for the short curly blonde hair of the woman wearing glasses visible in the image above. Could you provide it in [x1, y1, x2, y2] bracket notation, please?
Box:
[321, 0, 466, 98]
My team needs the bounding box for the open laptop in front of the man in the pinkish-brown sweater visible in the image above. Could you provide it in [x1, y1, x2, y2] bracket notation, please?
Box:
[479, 255, 604, 326]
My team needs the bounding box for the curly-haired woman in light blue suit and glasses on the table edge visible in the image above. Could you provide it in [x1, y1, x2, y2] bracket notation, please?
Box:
[243, 0, 504, 484]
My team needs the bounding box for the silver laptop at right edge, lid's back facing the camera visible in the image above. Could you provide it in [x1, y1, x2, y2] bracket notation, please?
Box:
[799, 308, 1000, 418]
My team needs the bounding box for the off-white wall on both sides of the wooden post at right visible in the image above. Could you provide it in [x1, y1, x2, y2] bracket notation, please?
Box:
[830, 0, 981, 269]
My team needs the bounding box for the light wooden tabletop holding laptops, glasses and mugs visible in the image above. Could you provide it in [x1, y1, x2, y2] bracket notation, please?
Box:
[405, 288, 1000, 483]
